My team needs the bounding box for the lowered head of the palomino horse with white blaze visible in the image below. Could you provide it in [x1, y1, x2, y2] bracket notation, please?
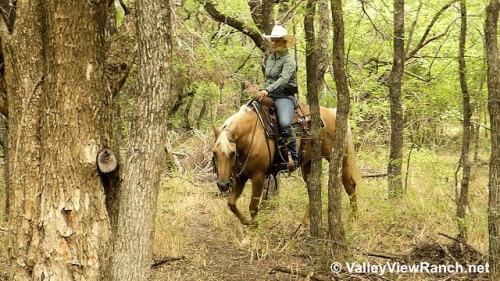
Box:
[212, 126, 238, 192]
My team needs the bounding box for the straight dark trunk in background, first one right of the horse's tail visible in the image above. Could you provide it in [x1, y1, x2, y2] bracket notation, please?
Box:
[387, 0, 405, 198]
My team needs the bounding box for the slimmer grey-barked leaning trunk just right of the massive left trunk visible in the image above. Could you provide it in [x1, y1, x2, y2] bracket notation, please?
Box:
[111, 0, 172, 281]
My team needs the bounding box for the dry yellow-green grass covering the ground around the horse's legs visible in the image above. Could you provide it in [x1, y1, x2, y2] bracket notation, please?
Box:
[0, 134, 488, 281]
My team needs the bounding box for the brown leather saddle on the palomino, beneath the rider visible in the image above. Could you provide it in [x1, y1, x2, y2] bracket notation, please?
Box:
[251, 97, 318, 175]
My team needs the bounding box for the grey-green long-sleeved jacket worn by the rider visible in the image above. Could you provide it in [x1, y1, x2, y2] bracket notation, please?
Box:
[264, 51, 297, 94]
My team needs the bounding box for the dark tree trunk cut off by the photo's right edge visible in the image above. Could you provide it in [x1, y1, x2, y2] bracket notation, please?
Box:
[484, 0, 500, 281]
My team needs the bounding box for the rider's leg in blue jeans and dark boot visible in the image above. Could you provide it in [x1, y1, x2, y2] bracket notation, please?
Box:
[269, 94, 299, 163]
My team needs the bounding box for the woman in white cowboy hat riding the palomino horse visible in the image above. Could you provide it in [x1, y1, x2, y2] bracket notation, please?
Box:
[257, 25, 299, 171]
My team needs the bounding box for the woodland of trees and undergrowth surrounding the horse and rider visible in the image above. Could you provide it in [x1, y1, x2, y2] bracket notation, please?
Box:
[0, 0, 500, 280]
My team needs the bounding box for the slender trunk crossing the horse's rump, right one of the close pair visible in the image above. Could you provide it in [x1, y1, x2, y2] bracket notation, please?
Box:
[328, 0, 350, 262]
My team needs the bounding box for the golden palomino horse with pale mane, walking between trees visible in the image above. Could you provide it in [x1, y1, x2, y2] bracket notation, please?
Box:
[212, 102, 361, 227]
